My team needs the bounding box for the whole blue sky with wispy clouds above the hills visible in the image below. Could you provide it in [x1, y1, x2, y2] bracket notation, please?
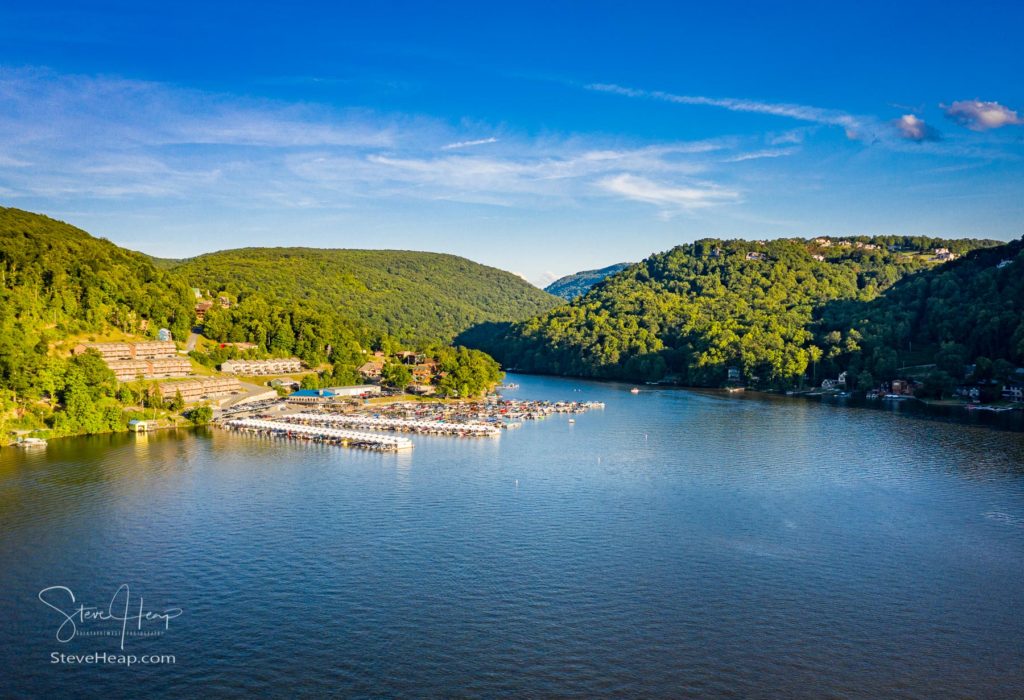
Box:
[0, 0, 1024, 283]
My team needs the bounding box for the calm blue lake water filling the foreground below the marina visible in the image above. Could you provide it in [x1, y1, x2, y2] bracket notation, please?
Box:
[0, 377, 1024, 698]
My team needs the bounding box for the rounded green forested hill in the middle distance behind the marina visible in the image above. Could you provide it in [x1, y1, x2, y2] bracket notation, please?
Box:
[173, 248, 558, 343]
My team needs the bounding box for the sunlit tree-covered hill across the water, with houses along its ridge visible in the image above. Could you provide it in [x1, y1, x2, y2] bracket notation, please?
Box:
[479, 236, 998, 387]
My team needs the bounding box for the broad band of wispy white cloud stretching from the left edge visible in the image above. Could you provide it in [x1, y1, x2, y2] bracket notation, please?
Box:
[0, 69, 741, 215]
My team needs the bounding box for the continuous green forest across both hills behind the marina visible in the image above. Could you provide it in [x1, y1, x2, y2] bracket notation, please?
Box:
[0, 209, 560, 439]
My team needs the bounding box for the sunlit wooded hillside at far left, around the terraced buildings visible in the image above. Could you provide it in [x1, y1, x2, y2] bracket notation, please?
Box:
[0, 208, 194, 433]
